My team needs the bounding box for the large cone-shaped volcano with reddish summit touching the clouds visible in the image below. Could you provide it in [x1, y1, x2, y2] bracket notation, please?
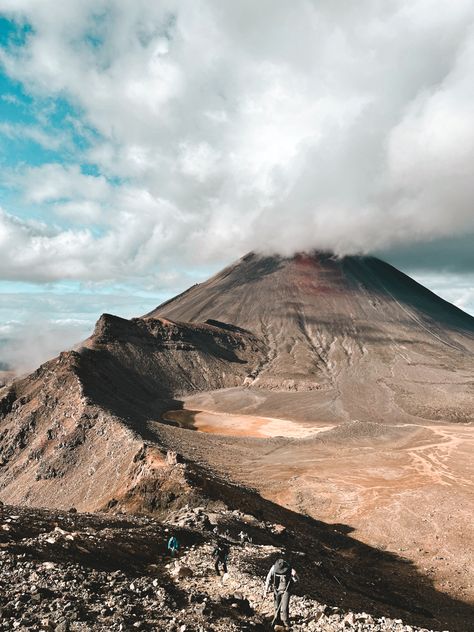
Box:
[150, 254, 474, 422]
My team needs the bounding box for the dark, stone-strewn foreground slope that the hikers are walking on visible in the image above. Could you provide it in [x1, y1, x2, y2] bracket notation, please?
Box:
[0, 498, 471, 632]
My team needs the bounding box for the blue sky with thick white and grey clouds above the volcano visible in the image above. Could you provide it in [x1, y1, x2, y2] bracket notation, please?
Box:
[0, 0, 474, 371]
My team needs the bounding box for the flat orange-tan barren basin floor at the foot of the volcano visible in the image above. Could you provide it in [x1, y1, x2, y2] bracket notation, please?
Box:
[158, 395, 474, 603]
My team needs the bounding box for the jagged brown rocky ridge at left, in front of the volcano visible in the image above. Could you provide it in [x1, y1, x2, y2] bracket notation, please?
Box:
[0, 315, 264, 511]
